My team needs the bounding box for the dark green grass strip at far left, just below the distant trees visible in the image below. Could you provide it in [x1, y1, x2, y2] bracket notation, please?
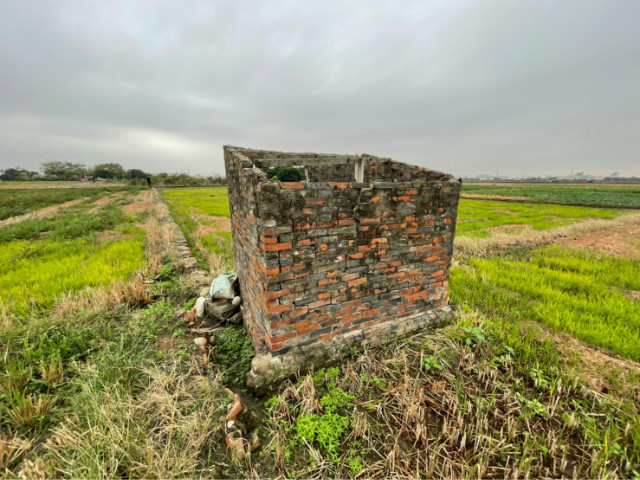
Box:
[0, 187, 140, 220]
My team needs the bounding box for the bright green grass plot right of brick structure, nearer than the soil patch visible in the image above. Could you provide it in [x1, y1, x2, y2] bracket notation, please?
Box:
[450, 246, 640, 361]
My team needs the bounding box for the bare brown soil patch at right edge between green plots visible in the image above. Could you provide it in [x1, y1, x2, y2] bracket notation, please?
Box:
[560, 225, 640, 260]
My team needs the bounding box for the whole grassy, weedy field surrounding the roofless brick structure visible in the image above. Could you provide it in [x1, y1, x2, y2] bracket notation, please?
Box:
[0, 183, 640, 478]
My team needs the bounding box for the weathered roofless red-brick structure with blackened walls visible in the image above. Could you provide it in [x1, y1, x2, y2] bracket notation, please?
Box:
[224, 146, 460, 388]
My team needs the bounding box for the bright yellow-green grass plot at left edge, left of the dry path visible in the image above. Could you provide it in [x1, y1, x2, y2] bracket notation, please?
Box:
[0, 196, 146, 315]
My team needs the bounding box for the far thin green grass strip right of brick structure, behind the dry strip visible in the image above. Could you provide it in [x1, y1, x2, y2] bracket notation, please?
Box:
[456, 198, 621, 237]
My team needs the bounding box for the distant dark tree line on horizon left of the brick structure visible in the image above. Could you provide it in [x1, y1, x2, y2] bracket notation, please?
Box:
[0, 162, 226, 186]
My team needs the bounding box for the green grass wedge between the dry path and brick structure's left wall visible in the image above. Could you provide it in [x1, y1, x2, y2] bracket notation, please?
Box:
[162, 187, 233, 273]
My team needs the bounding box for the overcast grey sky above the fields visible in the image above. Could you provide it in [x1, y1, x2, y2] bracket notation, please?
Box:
[0, 0, 640, 176]
